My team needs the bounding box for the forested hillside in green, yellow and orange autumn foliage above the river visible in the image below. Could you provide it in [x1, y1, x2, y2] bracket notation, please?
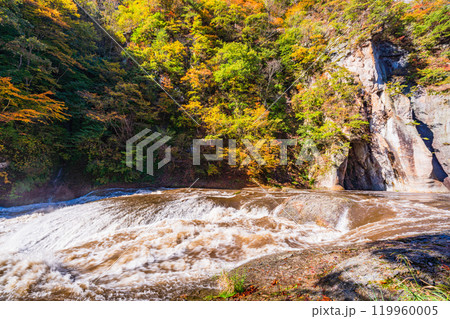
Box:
[0, 0, 450, 202]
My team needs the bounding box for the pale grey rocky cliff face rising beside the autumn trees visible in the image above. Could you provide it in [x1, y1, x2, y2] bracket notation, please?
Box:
[318, 43, 450, 192]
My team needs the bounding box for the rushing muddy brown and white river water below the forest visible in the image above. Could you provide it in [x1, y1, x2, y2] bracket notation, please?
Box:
[0, 190, 450, 299]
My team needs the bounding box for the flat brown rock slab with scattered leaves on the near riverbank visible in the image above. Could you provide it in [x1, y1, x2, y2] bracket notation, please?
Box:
[179, 234, 450, 300]
